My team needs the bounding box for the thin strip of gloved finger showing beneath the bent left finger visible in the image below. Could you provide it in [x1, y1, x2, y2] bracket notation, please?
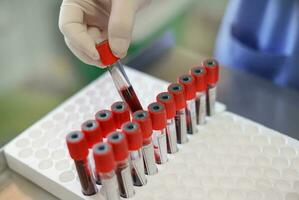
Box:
[65, 38, 105, 68]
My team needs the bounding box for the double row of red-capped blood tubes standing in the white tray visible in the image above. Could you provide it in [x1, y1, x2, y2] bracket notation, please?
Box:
[66, 56, 219, 200]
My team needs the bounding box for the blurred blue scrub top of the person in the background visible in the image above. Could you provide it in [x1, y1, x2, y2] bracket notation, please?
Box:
[215, 0, 299, 89]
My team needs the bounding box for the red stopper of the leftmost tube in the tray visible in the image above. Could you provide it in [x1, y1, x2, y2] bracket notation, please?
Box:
[66, 131, 88, 160]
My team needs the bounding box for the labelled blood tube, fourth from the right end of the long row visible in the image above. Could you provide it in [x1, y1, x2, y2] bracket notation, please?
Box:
[168, 83, 188, 144]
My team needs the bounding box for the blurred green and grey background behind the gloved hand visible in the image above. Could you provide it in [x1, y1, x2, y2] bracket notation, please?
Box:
[0, 0, 227, 147]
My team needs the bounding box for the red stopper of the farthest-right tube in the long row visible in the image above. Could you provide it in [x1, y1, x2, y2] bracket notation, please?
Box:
[202, 59, 219, 85]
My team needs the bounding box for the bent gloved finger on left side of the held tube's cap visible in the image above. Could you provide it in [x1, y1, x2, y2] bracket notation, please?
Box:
[59, 5, 99, 60]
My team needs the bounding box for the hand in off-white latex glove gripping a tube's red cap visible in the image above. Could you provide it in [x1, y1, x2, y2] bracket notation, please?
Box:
[59, 0, 150, 67]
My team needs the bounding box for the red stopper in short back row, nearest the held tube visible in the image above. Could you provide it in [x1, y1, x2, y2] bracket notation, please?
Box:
[111, 101, 131, 129]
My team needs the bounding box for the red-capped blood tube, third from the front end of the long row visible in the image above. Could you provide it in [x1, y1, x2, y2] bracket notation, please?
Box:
[122, 122, 147, 186]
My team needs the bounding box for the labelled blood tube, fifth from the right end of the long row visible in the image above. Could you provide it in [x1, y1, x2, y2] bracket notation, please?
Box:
[157, 92, 179, 154]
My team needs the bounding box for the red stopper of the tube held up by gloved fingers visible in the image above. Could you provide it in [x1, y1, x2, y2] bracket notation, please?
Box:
[96, 40, 119, 66]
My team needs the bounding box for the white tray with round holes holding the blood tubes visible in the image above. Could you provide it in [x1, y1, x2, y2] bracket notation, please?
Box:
[5, 68, 299, 200]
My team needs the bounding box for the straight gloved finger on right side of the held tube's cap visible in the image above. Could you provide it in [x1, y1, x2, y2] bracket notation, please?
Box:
[108, 0, 137, 58]
